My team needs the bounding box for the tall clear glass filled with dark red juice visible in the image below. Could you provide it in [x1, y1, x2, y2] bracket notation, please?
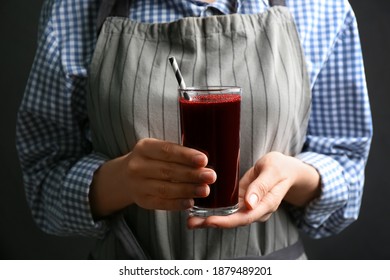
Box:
[179, 86, 241, 217]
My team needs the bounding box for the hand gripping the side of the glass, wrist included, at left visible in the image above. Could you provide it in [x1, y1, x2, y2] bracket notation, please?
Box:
[89, 138, 216, 218]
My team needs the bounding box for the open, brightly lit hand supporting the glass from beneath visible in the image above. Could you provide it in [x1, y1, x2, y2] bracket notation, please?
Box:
[188, 152, 320, 228]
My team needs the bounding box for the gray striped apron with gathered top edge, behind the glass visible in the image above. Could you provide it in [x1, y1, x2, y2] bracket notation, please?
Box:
[87, 1, 311, 259]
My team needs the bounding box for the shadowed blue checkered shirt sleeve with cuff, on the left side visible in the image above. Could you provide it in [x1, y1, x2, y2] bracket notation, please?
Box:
[16, 0, 106, 236]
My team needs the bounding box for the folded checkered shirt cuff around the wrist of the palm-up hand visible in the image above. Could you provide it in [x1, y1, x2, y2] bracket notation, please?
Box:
[293, 152, 348, 238]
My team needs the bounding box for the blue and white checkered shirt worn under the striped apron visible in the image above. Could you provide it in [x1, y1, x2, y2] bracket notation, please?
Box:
[17, 0, 372, 238]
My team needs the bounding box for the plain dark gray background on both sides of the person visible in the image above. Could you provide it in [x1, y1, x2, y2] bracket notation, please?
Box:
[0, 0, 390, 259]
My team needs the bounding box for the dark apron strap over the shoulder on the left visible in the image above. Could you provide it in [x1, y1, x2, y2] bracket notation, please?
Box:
[96, 0, 130, 34]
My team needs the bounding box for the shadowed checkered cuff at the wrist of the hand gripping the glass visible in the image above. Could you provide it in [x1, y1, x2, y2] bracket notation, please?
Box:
[63, 153, 108, 237]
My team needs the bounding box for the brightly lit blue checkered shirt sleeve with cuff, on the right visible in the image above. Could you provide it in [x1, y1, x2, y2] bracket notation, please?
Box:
[293, 1, 372, 238]
